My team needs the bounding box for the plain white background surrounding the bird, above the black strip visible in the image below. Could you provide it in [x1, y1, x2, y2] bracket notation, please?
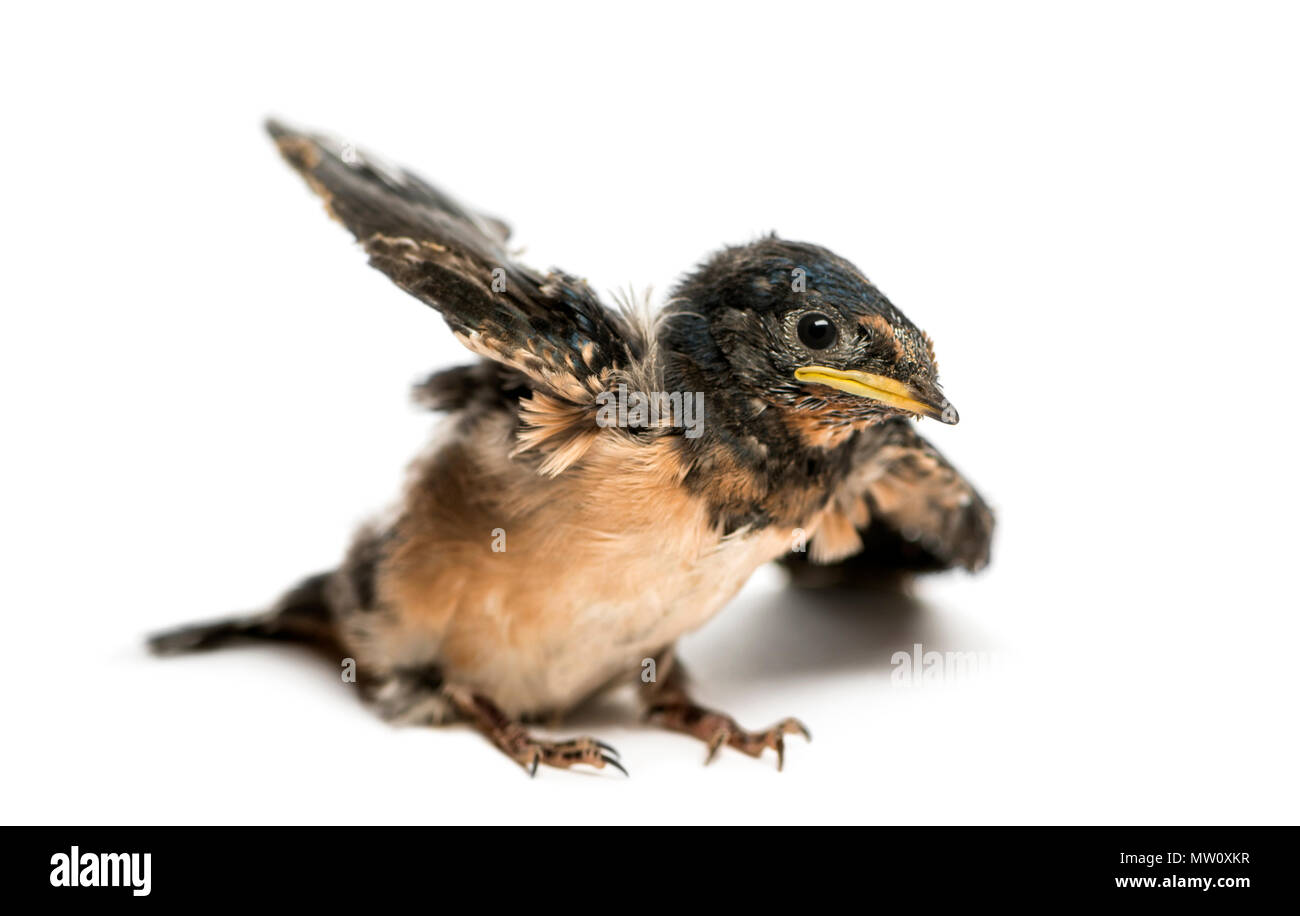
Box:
[0, 3, 1300, 824]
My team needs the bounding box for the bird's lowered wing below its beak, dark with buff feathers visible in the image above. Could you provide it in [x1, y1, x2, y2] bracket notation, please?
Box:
[784, 418, 993, 585]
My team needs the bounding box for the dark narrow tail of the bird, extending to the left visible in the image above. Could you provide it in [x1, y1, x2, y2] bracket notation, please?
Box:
[148, 573, 334, 655]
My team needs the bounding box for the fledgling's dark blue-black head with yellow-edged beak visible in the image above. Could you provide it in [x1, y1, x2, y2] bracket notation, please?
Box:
[670, 236, 957, 438]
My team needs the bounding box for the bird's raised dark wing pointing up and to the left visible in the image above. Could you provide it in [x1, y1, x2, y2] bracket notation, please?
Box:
[267, 121, 641, 405]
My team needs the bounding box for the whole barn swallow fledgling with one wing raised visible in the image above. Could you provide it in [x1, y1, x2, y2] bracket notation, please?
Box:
[151, 122, 993, 773]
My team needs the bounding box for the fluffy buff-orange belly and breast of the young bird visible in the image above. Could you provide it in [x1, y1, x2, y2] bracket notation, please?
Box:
[369, 420, 790, 715]
